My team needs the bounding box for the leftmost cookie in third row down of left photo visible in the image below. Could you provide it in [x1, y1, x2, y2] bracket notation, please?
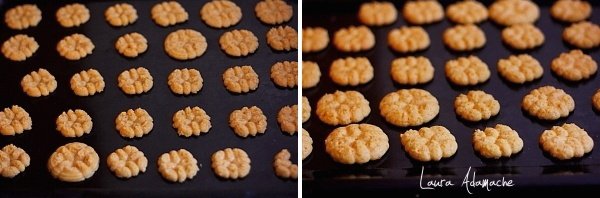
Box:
[21, 68, 58, 97]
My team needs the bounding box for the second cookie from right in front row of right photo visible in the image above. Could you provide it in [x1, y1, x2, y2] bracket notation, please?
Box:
[473, 124, 523, 159]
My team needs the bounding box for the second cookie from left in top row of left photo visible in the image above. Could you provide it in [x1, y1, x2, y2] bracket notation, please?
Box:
[56, 3, 90, 28]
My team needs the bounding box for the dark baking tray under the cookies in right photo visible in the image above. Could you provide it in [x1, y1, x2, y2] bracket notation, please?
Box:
[302, 0, 600, 195]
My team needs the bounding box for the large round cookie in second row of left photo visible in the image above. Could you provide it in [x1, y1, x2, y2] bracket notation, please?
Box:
[164, 29, 208, 60]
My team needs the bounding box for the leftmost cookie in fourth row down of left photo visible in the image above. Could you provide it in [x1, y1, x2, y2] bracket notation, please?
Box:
[0, 105, 32, 136]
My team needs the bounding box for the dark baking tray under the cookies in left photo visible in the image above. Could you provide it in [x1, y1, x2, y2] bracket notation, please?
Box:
[0, 0, 298, 197]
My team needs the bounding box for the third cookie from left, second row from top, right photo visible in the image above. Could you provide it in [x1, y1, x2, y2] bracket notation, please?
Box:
[388, 26, 430, 53]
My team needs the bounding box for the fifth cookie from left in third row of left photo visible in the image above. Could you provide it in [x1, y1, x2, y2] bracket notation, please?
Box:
[223, 65, 259, 93]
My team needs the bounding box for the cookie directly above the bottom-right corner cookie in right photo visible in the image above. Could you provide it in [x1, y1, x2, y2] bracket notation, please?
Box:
[522, 86, 575, 120]
